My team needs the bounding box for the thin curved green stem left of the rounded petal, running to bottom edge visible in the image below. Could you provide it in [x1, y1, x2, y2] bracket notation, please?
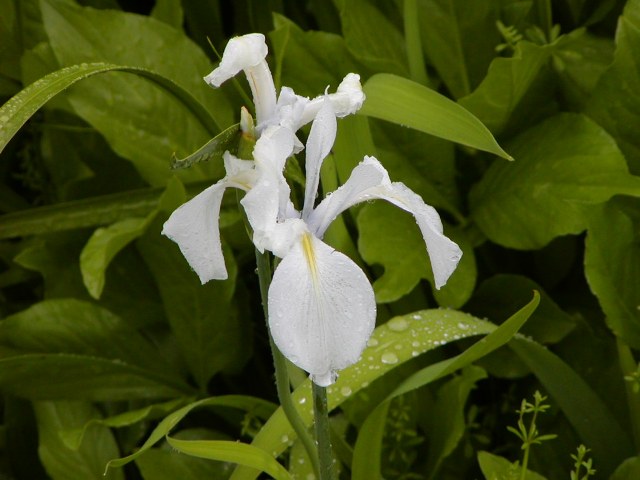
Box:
[256, 250, 322, 478]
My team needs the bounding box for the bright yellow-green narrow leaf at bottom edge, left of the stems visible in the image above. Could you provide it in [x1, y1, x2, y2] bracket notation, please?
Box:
[167, 437, 292, 480]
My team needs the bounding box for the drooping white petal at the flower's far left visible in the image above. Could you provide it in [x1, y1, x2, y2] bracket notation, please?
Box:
[162, 180, 228, 284]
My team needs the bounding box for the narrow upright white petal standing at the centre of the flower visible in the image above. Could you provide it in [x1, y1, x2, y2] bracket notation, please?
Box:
[302, 100, 337, 218]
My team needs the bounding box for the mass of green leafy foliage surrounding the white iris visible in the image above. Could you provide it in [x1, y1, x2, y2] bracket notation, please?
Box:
[0, 0, 640, 480]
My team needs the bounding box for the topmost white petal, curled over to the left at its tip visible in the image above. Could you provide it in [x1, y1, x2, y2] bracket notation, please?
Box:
[204, 33, 276, 130]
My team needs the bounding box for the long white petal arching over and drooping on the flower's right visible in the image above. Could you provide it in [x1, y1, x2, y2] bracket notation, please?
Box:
[307, 157, 462, 289]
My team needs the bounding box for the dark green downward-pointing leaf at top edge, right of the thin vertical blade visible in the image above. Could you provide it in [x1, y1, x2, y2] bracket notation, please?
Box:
[418, 0, 500, 98]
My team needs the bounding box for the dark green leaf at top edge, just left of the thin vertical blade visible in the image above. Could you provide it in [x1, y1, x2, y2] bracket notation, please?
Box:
[340, 0, 408, 76]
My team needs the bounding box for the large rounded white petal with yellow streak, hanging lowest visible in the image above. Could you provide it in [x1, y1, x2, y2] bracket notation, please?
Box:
[269, 232, 376, 386]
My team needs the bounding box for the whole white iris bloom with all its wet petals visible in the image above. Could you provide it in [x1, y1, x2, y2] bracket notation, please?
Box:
[162, 34, 462, 386]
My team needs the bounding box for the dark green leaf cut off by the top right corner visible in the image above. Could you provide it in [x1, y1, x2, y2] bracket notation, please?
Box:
[585, 0, 640, 174]
